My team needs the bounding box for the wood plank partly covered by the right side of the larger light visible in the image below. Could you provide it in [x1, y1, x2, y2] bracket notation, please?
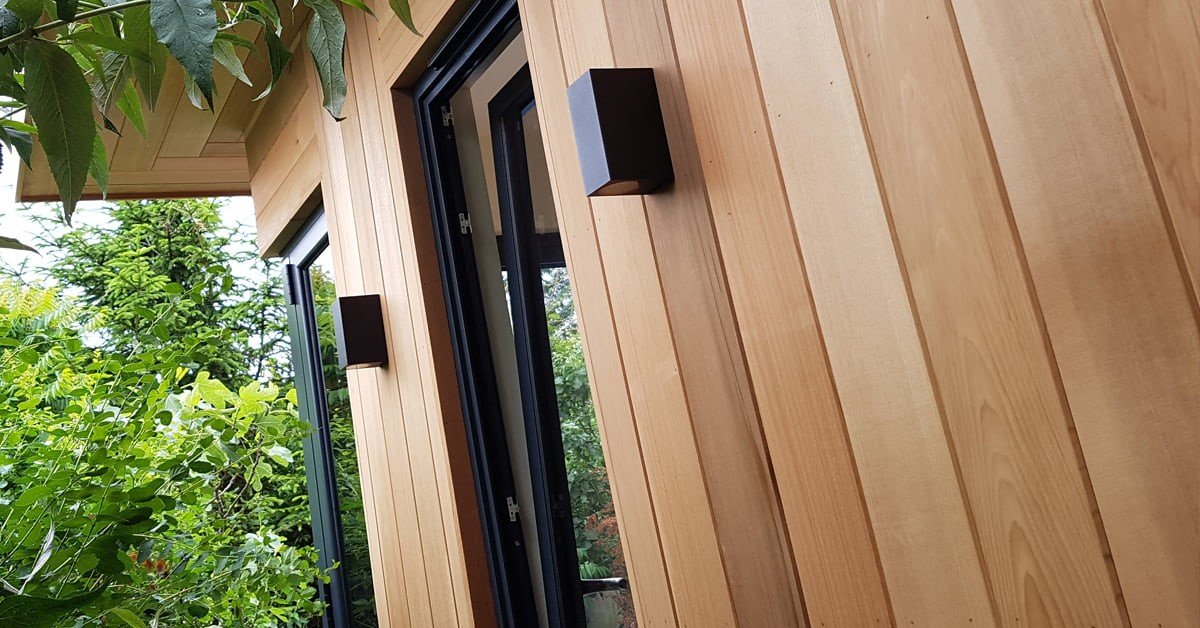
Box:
[600, 0, 804, 627]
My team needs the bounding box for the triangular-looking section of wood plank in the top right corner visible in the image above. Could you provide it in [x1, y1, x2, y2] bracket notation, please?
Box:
[1097, 0, 1200, 300]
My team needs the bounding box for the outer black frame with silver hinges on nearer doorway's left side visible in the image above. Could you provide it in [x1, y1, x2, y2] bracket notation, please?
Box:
[413, 0, 538, 628]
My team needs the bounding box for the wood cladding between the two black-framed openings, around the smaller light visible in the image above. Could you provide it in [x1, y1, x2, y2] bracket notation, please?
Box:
[247, 1, 496, 627]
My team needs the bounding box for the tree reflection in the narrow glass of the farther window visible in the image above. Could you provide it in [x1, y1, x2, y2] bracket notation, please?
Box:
[308, 262, 379, 627]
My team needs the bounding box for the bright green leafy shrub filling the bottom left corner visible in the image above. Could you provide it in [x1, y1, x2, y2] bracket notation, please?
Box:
[0, 281, 319, 627]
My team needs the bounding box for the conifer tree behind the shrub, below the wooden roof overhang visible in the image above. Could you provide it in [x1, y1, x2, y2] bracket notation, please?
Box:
[44, 199, 289, 385]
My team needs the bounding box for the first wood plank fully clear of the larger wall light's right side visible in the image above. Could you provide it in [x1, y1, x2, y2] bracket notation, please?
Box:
[666, 0, 892, 626]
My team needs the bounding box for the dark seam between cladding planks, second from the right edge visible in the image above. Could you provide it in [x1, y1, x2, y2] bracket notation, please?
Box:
[942, 0, 1129, 626]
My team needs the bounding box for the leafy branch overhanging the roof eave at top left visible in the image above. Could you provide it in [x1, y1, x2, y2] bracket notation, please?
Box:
[0, 0, 416, 223]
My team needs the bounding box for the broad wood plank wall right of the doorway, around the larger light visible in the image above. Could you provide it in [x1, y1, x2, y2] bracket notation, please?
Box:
[521, 0, 1200, 627]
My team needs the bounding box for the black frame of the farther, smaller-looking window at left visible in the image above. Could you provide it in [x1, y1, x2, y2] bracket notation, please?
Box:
[283, 208, 352, 628]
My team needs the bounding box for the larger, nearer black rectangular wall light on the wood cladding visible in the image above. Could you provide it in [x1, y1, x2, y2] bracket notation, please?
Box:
[566, 67, 674, 196]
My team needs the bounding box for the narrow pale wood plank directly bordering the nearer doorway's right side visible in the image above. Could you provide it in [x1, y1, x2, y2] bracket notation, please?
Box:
[520, 0, 677, 627]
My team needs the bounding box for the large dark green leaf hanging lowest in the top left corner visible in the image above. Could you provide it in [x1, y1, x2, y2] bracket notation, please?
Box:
[25, 40, 96, 222]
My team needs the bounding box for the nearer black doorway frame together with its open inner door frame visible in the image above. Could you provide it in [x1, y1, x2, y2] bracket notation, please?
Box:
[413, 0, 584, 628]
